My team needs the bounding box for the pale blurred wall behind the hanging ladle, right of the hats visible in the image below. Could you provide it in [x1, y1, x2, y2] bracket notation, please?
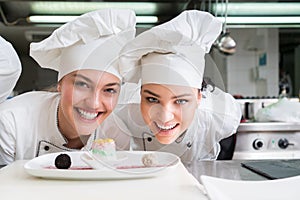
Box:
[213, 28, 279, 96]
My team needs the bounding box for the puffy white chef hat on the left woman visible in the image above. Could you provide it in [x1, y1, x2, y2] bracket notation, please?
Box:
[30, 9, 136, 80]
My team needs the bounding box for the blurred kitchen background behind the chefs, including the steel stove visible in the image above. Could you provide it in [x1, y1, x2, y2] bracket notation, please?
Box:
[0, 0, 300, 159]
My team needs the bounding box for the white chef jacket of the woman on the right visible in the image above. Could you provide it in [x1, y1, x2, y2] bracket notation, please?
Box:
[116, 88, 242, 163]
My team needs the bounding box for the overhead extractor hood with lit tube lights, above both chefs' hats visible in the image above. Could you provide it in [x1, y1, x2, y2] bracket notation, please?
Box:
[0, 0, 300, 28]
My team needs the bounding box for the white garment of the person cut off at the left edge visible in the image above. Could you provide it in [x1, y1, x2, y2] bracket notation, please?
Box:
[0, 36, 22, 103]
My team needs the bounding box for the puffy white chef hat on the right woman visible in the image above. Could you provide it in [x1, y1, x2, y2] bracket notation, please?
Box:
[119, 10, 222, 88]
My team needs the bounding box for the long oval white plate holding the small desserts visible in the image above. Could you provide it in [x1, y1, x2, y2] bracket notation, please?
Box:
[24, 151, 179, 180]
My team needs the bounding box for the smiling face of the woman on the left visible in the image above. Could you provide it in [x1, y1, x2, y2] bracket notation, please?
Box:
[57, 69, 120, 139]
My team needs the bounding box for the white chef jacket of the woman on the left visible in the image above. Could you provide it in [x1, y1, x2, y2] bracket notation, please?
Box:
[0, 91, 130, 165]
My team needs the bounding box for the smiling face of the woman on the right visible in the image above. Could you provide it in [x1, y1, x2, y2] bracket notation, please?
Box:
[141, 84, 201, 144]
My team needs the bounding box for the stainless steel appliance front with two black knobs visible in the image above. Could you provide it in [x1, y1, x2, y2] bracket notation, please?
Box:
[233, 122, 300, 160]
